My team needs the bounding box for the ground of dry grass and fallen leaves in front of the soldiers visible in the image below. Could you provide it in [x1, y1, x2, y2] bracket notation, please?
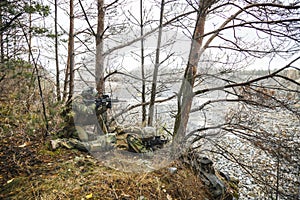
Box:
[0, 132, 211, 200]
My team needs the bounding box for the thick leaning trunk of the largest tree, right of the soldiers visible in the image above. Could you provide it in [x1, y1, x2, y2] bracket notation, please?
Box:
[174, 1, 206, 142]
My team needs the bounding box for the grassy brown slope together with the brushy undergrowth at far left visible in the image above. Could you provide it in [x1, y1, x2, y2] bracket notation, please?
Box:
[0, 62, 211, 200]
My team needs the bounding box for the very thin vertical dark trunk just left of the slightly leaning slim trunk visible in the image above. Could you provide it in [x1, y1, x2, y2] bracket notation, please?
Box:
[140, 0, 147, 124]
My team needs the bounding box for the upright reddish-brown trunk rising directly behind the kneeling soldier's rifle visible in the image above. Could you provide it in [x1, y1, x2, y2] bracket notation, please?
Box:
[95, 0, 105, 96]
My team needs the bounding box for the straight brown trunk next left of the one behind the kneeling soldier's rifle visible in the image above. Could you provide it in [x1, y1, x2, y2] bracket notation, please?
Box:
[67, 0, 75, 103]
